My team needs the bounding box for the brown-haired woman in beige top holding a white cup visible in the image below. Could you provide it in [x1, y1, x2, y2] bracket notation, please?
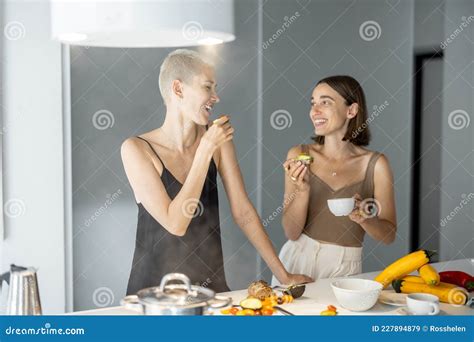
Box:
[273, 76, 397, 284]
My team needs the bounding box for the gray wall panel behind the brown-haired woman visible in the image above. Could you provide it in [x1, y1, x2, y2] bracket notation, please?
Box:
[263, 0, 414, 280]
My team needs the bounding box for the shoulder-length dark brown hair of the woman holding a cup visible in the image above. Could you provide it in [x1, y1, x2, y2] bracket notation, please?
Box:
[312, 75, 370, 146]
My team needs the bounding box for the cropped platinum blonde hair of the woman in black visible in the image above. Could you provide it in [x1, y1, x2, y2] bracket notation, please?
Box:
[158, 49, 212, 104]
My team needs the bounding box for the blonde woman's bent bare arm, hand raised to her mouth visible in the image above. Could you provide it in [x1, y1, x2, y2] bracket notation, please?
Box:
[121, 125, 233, 236]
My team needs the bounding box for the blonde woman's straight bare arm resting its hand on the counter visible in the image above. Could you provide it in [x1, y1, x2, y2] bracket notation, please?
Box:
[218, 141, 312, 284]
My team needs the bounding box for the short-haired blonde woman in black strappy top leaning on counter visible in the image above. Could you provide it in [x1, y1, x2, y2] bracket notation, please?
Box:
[122, 50, 311, 294]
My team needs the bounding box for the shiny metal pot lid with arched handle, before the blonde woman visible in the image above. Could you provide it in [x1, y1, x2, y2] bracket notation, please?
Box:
[137, 273, 215, 308]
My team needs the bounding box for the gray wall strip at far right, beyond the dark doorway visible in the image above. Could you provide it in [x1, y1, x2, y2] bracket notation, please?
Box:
[439, 0, 474, 260]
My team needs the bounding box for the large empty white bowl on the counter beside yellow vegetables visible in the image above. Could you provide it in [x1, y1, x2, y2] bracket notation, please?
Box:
[331, 278, 383, 311]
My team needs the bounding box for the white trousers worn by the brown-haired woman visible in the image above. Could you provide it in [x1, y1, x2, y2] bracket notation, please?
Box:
[272, 234, 362, 286]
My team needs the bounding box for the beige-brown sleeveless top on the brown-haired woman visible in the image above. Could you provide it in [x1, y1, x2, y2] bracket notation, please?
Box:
[301, 145, 381, 247]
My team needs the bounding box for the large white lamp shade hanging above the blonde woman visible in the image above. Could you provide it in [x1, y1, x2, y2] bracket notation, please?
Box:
[51, 0, 235, 48]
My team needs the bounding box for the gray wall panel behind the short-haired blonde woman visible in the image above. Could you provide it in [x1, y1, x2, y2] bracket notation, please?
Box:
[71, 1, 258, 310]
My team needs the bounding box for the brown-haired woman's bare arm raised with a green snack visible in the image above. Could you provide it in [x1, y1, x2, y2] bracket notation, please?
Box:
[282, 146, 310, 240]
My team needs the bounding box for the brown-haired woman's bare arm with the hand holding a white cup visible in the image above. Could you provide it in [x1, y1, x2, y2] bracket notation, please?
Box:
[349, 155, 397, 245]
